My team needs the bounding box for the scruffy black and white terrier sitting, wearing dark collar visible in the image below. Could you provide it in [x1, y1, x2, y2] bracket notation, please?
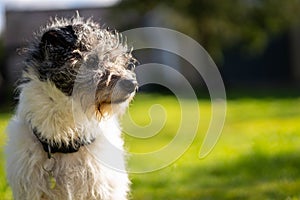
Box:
[6, 15, 137, 200]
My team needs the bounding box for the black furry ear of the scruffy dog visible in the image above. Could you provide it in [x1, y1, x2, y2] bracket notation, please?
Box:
[40, 26, 77, 56]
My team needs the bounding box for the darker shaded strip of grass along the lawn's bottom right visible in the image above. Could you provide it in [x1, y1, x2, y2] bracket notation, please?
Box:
[132, 152, 300, 200]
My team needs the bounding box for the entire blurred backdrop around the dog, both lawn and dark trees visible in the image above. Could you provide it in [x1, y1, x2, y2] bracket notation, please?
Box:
[0, 0, 300, 199]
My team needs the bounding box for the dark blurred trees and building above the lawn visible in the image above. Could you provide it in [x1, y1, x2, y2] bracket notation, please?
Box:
[0, 0, 300, 102]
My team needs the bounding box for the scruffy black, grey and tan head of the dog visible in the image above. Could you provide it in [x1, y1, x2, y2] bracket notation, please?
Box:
[23, 17, 137, 118]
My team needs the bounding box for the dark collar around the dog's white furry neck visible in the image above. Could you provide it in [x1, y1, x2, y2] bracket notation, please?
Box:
[32, 127, 96, 159]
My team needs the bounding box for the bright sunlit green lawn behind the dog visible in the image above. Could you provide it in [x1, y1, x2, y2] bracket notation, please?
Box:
[0, 95, 300, 200]
